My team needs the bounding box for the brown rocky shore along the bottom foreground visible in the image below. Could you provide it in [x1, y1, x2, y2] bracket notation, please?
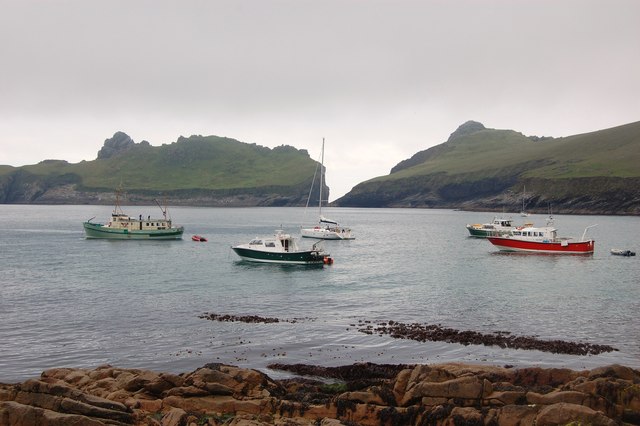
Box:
[0, 363, 640, 426]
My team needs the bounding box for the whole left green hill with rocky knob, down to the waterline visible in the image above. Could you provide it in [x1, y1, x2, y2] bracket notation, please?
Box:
[0, 132, 328, 205]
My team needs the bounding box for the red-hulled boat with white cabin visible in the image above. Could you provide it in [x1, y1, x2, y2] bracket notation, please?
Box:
[487, 218, 596, 254]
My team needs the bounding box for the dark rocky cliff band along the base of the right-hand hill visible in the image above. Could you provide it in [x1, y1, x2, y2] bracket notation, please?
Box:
[335, 176, 640, 215]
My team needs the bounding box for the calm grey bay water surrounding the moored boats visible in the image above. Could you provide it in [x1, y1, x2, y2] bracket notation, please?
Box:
[0, 205, 640, 382]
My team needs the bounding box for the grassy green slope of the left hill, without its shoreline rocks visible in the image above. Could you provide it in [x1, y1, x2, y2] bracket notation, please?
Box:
[16, 136, 316, 190]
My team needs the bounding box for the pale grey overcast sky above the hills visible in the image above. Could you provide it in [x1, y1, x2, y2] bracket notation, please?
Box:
[0, 0, 640, 200]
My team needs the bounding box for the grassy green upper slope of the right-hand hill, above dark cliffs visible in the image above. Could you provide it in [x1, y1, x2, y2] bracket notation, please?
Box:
[380, 122, 640, 181]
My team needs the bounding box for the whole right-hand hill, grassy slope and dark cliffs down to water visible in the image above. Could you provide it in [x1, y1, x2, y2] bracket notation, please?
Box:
[335, 122, 640, 214]
